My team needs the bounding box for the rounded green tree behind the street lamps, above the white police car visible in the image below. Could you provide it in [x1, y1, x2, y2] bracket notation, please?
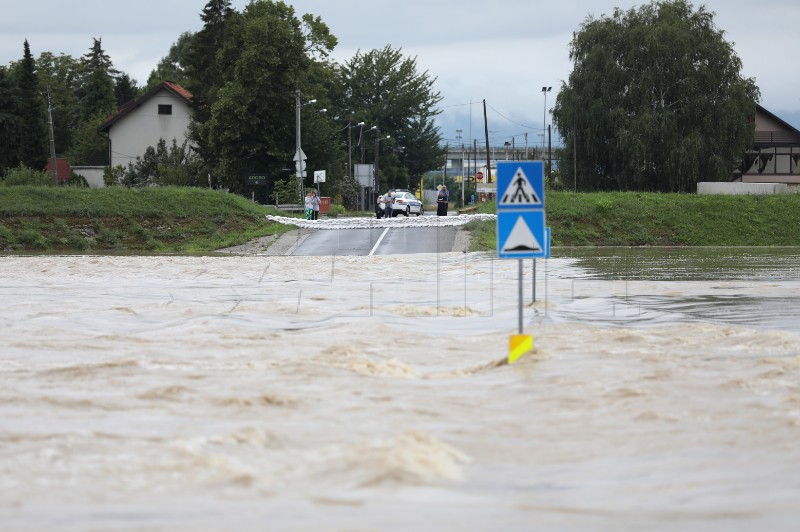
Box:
[334, 46, 444, 189]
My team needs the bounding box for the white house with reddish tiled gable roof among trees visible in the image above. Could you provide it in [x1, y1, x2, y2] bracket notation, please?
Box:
[98, 81, 192, 168]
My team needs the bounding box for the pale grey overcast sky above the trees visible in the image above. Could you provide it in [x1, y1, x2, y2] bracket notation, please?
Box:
[0, 0, 800, 146]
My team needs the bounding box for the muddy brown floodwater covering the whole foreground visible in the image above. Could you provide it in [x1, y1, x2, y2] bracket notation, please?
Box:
[0, 248, 800, 530]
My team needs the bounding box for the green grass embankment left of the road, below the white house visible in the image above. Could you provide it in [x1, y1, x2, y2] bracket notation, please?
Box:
[0, 186, 290, 253]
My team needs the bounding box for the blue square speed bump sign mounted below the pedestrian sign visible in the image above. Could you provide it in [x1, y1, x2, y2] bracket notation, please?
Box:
[497, 210, 547, 259]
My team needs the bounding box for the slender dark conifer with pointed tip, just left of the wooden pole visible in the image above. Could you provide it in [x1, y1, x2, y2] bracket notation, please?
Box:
[17, 39, 48, 170]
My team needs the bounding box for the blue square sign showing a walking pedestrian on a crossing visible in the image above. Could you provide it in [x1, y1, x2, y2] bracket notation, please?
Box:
[497, 161, 544, 212]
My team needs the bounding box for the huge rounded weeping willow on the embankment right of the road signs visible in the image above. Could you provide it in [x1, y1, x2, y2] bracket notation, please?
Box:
[553, 0, 760, 192]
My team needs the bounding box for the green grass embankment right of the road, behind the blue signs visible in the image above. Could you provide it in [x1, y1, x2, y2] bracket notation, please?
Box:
[467, 191, 800, 250]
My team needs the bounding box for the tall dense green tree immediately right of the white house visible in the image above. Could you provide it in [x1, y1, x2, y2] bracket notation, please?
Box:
[202, 0, 336, 197]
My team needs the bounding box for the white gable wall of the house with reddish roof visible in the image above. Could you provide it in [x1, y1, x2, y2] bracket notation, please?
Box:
[109, 89, 191, 168]
